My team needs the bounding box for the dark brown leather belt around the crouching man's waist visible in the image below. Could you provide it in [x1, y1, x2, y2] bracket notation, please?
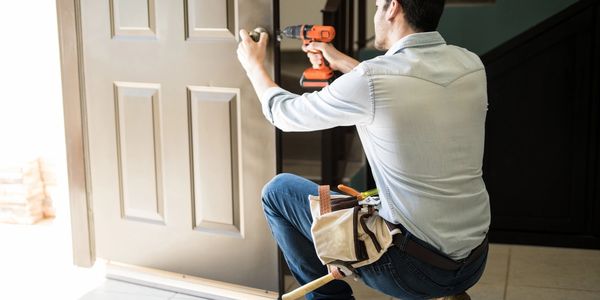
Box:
[386, 221, 488, 271]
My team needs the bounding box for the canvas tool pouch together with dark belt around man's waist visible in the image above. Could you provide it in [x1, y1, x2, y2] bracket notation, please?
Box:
[309, 185, 488, 272]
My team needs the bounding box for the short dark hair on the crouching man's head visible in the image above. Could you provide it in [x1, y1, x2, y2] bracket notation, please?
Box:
[383, 0, 446, 32]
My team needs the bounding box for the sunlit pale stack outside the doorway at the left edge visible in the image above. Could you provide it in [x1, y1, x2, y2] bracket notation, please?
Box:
[0, 158, 54, 224]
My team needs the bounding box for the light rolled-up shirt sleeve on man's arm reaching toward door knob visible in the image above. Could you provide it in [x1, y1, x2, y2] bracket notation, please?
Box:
[260, 65, 374, 131]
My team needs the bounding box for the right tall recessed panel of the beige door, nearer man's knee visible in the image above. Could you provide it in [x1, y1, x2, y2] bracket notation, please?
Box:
[189, 87, 242, 238]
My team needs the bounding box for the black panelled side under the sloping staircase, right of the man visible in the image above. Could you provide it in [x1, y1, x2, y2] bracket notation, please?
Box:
[482, 0, 600, 248]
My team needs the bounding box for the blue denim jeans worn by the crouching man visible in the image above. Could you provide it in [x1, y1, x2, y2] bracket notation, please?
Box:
[262, 173, 487, 299]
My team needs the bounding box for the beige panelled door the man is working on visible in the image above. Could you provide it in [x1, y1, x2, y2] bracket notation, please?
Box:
[80, 0, 277, 291]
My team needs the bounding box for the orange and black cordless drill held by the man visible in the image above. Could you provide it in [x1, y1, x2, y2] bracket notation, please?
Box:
[281, 24, 335, 88]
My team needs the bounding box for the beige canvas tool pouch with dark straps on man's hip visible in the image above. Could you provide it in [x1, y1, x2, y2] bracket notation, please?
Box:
[309, 186, 392, 268]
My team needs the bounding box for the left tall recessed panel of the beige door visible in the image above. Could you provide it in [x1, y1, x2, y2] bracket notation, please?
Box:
[115, 82, 164, 223]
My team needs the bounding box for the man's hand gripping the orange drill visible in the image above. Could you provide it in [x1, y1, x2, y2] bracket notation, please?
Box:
[302, 42, 359, 73]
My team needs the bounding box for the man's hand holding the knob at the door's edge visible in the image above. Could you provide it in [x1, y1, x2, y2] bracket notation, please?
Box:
[237, 29, 269, 76]
